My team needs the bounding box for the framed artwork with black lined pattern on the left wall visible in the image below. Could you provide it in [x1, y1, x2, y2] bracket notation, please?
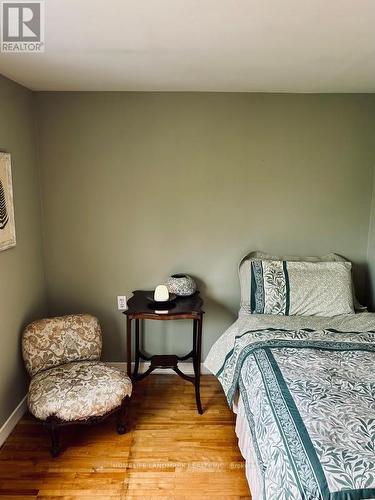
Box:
[0, 153, 16, 251]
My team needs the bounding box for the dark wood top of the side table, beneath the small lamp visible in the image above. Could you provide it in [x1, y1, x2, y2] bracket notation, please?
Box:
[124, 290, 204, 319]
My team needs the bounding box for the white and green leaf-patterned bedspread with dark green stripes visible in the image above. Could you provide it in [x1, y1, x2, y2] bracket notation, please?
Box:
[216, 328, 375, 500]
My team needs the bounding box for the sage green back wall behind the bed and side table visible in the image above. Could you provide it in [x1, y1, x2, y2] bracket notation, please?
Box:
[37, 92, 375, 360]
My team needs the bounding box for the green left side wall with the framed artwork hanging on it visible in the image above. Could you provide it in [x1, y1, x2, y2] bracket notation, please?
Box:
[0, 76, 46, 427]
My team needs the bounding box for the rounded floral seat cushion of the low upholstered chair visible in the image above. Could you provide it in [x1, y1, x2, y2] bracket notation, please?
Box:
[28, 361, 132, 421]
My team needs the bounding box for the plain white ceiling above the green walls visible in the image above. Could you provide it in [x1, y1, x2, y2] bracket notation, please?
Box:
[0, 0, 375, 92]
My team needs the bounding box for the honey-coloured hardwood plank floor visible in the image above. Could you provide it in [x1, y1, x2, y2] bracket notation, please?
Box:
[0, 375, 251, 500]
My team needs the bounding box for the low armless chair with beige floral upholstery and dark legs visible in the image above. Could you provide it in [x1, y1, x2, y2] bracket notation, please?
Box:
[22, 314, 132, 456]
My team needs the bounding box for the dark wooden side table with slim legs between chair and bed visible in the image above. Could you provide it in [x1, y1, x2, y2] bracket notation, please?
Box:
[124, 290, 204, 414]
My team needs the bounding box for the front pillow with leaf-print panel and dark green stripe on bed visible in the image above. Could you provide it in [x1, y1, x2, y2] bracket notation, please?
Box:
[250, 259, 354, 317]
